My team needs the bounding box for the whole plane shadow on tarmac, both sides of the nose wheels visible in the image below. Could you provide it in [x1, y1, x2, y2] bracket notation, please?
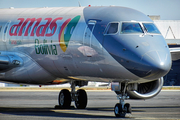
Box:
[0, 106, 180, 119]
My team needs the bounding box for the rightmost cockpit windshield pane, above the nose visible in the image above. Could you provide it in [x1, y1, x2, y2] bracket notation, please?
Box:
[143, 23, 161, 34]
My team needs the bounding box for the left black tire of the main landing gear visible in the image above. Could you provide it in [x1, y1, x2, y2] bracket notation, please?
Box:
[58, 89, 71, 109]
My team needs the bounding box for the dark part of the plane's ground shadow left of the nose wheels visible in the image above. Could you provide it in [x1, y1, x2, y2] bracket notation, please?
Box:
[0, 107, 115, 118]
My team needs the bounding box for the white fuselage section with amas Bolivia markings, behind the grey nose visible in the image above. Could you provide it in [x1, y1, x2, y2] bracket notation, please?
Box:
[0, 7, 172, 84]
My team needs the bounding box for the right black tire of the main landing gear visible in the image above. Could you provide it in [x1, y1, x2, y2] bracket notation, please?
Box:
[75, 89, 87, 109]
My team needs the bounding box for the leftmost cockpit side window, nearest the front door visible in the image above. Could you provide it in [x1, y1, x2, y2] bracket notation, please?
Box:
[106, 23, 119, 34]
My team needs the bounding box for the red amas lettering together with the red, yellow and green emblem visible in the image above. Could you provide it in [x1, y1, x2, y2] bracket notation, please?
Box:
[9, 15, 81, 52]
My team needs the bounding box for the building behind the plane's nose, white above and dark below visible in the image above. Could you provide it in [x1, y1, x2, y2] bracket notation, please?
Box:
[154, 20, 180, 86]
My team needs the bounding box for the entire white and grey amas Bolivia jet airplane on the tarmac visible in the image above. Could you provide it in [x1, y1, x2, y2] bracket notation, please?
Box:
[0, 6, 178, 117]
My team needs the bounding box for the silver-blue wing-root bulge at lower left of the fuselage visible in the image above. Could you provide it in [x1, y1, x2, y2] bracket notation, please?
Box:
[0, 52, 56, 84]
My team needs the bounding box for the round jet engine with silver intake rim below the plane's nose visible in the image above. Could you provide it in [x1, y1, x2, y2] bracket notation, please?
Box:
[127, 77, 164, 99]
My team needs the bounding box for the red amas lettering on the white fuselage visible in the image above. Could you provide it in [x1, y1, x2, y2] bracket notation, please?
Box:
[9, 17, 63, 37]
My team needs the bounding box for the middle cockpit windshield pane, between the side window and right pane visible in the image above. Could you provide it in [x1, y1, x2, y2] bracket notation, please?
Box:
[121, 22, 143, 34]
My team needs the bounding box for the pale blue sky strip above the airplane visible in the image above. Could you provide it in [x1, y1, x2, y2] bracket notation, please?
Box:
[0, 0, 180, 20]
